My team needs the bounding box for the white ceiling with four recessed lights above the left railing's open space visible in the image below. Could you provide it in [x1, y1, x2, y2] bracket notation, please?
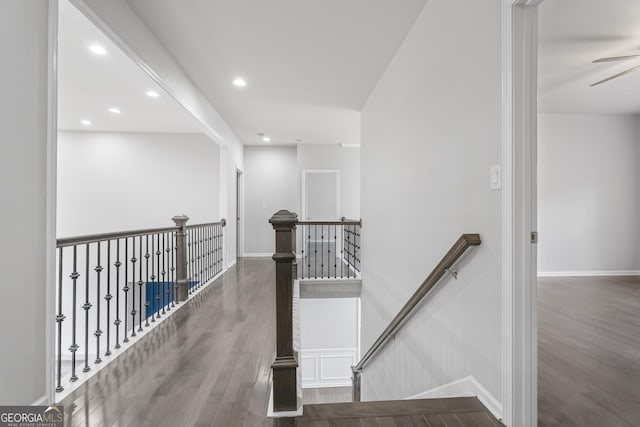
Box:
[58, 0, 200, 133]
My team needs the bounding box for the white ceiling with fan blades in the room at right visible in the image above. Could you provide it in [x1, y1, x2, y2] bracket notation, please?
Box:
[538, 0, 640, 114]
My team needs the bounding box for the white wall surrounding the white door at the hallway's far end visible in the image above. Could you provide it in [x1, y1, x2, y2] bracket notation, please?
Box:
[298, 144, 360, 219]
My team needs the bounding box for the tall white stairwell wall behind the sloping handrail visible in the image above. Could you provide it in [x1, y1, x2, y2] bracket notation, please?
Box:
[361, 0, 502, 408]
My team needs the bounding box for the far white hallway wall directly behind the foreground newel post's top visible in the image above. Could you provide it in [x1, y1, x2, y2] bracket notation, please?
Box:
[244, 146, 300, 256]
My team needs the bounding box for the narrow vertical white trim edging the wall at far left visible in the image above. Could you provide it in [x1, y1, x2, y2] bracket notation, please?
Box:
[45, 0, 58, 404]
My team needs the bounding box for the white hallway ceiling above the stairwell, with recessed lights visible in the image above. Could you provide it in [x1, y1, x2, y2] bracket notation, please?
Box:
[128, 0, 426, 144]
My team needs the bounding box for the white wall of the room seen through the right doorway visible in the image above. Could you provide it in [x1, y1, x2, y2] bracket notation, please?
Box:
[538, 114, 640, 274]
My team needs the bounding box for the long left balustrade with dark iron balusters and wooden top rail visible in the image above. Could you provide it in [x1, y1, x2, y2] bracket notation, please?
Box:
[55, 215, 226, 393]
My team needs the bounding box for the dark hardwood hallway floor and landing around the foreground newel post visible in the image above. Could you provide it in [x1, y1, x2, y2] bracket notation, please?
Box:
[61, 258, 500, 427]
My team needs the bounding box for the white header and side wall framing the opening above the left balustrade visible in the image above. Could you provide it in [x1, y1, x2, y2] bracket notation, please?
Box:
[71, 0, 244, 265]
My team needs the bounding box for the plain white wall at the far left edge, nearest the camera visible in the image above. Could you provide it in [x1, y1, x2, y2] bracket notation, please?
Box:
[0, 0, 55, 405]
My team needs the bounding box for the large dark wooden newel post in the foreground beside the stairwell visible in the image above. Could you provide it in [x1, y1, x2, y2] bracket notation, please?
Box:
[269, 210, 298, 412]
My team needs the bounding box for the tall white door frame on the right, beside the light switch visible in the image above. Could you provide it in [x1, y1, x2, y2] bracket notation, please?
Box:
[501, 0, 543, 427]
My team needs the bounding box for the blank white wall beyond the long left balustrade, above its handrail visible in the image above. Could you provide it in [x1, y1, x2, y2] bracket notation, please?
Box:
[57, 132, 222, 237]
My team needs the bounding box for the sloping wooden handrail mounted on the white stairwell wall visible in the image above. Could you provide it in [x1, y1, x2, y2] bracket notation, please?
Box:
[351, 234, 481, 401]
